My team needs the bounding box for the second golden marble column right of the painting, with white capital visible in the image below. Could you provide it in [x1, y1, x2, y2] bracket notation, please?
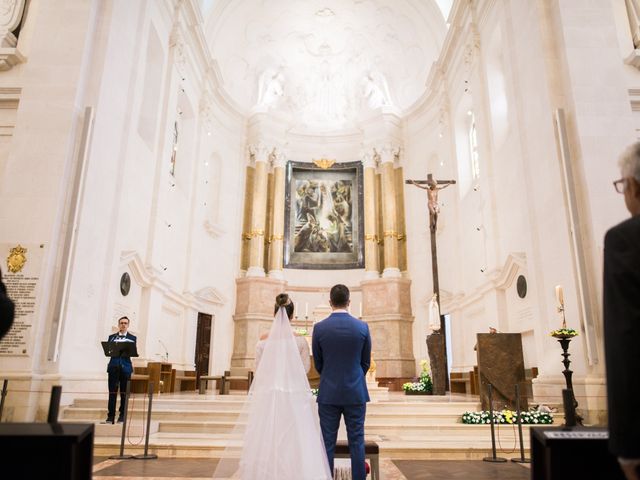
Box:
[378, 145, 400, 278]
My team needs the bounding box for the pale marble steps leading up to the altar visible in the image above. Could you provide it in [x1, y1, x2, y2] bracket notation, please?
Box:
[60, 388, 562, 460]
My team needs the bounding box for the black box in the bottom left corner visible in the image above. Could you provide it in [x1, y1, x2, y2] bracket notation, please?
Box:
[0, 423, 94, 480]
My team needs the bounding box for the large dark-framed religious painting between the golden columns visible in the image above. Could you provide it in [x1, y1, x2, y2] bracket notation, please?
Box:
[284, 162, 364, 270]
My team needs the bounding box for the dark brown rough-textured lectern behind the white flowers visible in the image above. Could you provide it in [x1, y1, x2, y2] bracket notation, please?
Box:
[476, 333, 528, 411]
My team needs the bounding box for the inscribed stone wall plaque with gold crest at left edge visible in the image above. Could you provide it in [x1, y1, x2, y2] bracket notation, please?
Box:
[0, 243, 44, 356]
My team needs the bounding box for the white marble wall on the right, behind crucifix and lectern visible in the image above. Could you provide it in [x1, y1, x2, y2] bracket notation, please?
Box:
[406, 1, 638, 418]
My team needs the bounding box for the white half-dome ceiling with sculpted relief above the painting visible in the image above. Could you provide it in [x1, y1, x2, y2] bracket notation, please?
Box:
[206, 0, 446, 132]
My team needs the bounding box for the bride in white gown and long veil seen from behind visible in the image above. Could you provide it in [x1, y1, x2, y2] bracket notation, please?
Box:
[213, 293, 332, 480]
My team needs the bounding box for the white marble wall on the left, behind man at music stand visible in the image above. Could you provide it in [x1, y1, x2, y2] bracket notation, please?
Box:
[0, 1, 243, 419]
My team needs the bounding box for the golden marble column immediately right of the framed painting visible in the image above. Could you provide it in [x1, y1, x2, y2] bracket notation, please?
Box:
[362, 152, 380, 279]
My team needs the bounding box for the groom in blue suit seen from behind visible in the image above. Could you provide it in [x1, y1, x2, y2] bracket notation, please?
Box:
[312, 285, 371, 480]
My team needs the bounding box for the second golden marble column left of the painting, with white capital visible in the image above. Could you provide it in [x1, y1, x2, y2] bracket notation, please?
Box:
[247, 145, 271, 277]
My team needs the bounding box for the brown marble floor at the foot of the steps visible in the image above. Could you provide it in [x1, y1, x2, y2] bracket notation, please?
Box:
[93, 458, 531, 480]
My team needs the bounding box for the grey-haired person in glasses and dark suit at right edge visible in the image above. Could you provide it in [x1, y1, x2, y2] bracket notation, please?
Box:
[603, 142, 640, 480]
